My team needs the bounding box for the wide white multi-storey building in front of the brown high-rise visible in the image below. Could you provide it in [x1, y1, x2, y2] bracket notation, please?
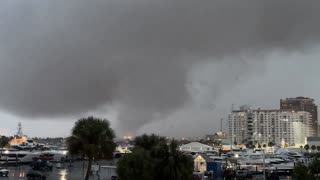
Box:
[228, 109, 312, 146]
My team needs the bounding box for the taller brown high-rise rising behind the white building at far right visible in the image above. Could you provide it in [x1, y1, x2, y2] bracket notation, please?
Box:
[280, 97, 318, 136]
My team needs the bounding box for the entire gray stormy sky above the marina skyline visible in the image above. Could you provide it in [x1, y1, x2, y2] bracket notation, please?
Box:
[0, 0, 320, 136]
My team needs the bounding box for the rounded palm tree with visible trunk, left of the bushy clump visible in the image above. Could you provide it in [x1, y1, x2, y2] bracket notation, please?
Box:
[67, 117, 116, 180]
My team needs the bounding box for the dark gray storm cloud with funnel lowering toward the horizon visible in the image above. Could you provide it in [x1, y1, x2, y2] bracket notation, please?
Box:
[0, 0, 320, 130]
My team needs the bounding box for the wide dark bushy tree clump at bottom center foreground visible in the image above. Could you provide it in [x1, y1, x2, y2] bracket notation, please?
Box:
[117, 135, 193, 180]
